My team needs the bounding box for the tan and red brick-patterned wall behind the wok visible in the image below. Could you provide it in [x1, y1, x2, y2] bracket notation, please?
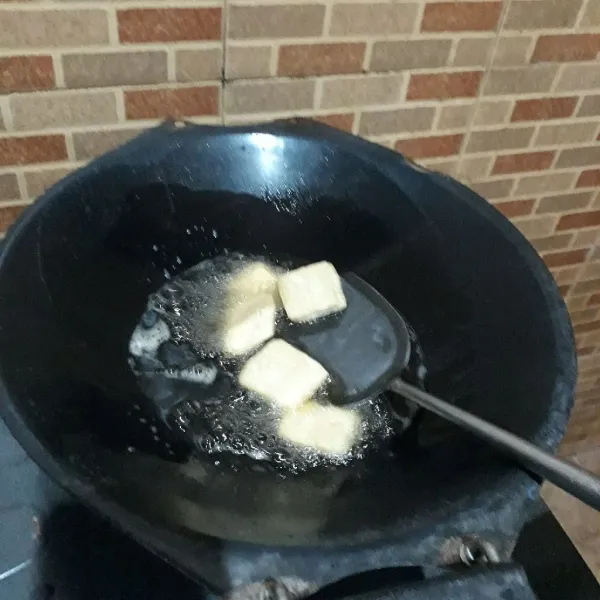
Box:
[0, 0, 600, 454]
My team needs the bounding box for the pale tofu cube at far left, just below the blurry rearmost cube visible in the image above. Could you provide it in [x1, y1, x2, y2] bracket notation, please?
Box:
[222, 293, 277, 356]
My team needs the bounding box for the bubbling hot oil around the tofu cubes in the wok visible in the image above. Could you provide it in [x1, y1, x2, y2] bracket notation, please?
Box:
[130, 253, 392, 473]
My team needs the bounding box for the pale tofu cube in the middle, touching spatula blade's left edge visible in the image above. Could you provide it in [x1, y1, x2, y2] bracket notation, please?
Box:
[239, 339, 329, 408]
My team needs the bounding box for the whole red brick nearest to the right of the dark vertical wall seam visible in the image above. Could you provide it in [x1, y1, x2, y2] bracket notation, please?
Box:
[277, 43, 366, 77]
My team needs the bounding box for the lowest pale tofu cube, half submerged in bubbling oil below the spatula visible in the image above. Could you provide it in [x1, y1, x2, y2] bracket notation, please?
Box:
[278, 402, 360, 455]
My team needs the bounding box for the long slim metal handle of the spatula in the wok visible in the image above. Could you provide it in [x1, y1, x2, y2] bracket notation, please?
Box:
[389, 379, 600, 510]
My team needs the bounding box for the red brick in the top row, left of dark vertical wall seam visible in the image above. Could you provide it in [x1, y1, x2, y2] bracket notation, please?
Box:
[117, 8, 221, 44]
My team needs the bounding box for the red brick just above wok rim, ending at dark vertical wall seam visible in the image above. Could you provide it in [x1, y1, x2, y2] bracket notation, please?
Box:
[124, 86, 219, 119]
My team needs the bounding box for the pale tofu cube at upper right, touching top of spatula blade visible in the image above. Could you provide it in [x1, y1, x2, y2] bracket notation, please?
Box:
[279, 261, 347, 323]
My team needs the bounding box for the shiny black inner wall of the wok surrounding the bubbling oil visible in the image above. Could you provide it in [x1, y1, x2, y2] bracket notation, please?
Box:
[0, 133, 572, 545]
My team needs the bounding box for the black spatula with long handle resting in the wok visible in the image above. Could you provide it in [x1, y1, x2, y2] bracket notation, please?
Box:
[284, 274, 600, 510]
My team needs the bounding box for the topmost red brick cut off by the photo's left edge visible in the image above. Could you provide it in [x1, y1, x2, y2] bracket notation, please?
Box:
[0, 55, 54, 92]
